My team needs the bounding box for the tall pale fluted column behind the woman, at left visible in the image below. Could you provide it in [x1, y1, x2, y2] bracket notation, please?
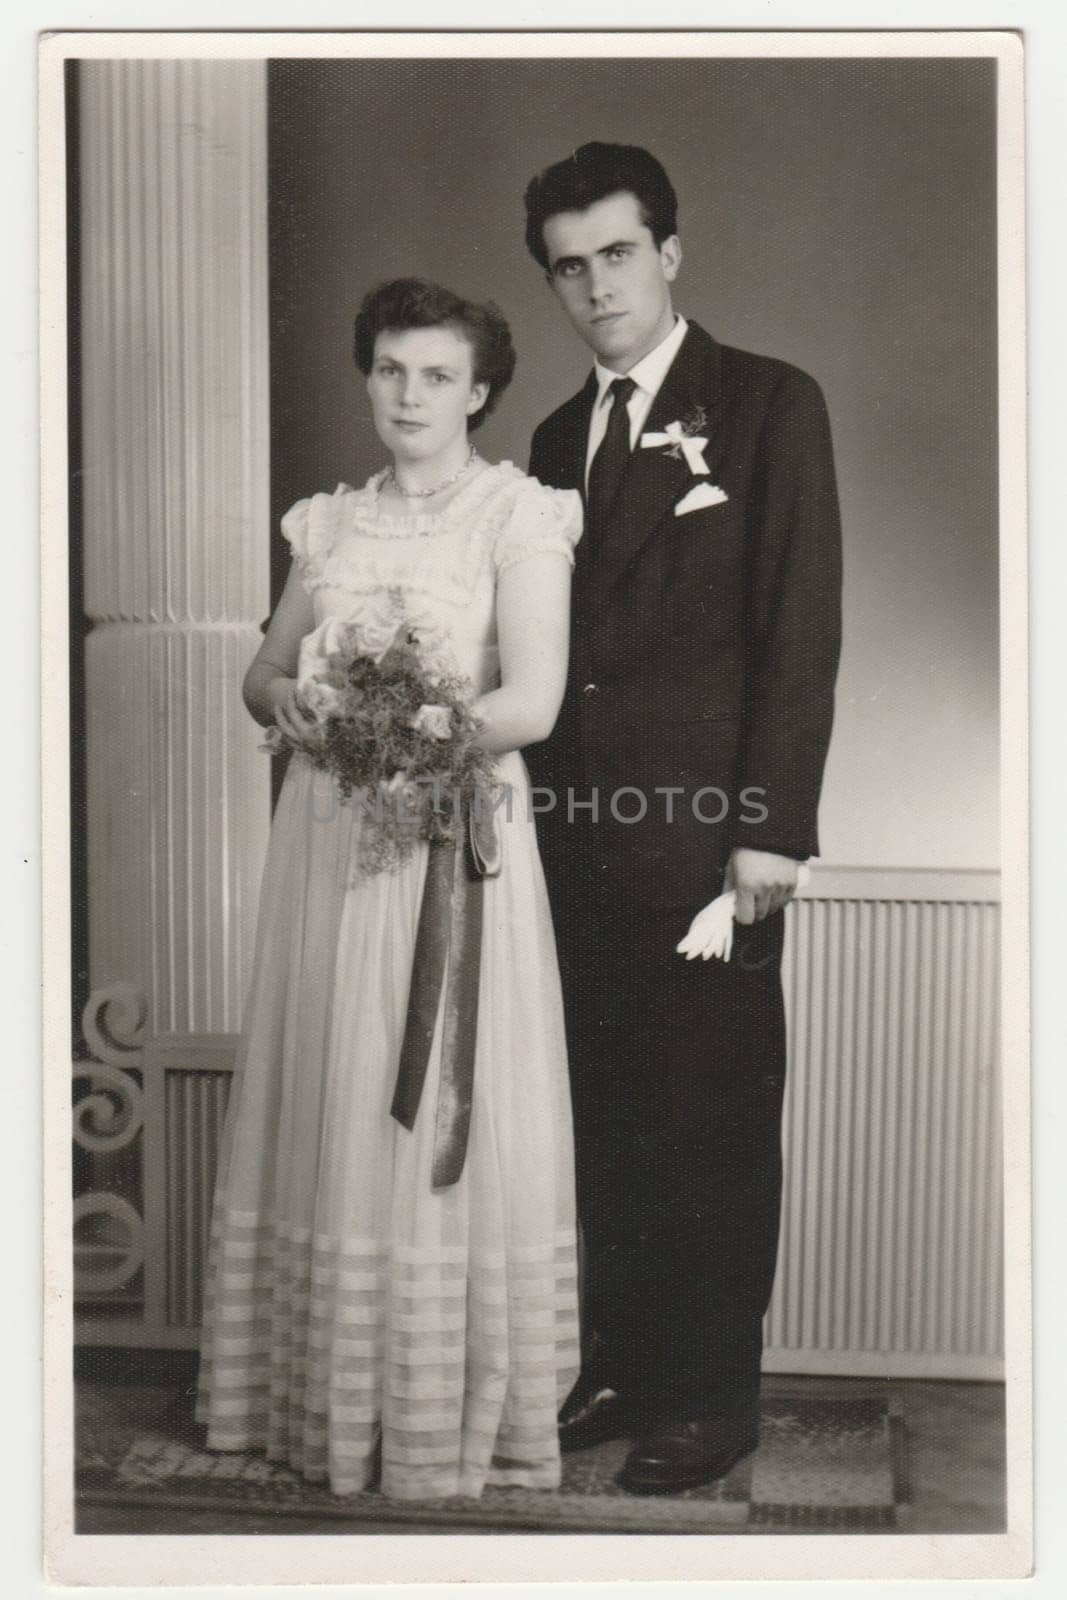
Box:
[80, 59, 269, 1034]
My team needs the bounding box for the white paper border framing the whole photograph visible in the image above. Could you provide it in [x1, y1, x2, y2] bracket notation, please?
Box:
[40, 18, 1032, 1587]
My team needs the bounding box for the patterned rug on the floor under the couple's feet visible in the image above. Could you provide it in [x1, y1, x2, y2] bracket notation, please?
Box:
[77, 1384, 909, 1533]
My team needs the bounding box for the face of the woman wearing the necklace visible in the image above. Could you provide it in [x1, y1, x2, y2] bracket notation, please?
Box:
[366, 326, 490, 461]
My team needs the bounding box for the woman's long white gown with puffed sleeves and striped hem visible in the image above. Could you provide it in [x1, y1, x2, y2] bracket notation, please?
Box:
[197, 462, 581, 1498]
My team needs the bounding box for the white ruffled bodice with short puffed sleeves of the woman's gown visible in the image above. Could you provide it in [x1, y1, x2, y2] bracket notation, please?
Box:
[282, 461, 582, 694]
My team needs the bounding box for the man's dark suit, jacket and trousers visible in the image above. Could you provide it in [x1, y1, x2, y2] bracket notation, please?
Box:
[528, 323, 840, 1418]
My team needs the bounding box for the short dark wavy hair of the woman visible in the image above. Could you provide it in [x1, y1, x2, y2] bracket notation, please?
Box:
[354, 278, 515, 430]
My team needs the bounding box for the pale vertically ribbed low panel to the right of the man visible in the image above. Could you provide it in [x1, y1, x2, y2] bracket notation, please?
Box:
[766, 870, 1003, 1378]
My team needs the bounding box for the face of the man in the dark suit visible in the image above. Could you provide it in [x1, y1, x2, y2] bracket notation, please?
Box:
[544, 194, 681, 373]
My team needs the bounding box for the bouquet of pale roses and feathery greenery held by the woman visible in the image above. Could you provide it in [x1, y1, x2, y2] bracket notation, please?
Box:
[267, 597, 494, 872]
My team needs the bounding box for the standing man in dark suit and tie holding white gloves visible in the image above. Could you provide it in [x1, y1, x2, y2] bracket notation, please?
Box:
[526, 144, 840, 1494]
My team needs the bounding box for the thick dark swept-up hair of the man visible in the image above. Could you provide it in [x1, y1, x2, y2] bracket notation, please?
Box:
[526, 141, 678, 272]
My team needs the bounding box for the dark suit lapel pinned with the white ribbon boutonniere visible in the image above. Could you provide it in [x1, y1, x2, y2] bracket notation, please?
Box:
[584, 323, 721, 597]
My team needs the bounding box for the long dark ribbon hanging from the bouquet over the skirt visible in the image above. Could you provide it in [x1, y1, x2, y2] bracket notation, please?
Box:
[390, 803, 501, 1189]
